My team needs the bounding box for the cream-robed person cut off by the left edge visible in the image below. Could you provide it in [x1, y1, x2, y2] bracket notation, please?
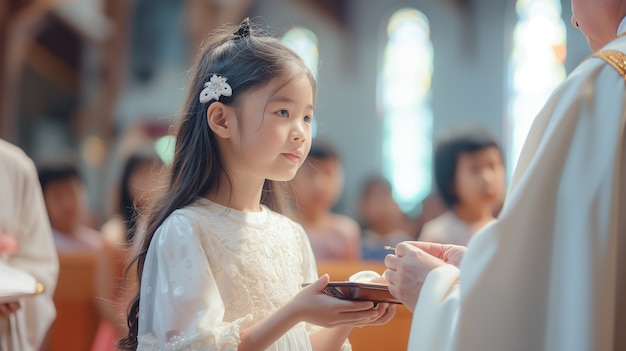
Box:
[0, 139, 59, 351]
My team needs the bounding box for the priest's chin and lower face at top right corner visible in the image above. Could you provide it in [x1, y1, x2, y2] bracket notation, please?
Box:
[572, 0, 624, 51]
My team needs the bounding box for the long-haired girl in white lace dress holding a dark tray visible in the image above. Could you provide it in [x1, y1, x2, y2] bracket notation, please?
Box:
[120, 20, 395, 351]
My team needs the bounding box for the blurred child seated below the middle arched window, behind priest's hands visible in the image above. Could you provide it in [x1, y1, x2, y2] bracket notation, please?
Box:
[358, 177, 417, 260]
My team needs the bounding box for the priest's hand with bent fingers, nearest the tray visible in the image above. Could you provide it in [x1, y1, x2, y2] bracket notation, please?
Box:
[383, 242, 446, 312]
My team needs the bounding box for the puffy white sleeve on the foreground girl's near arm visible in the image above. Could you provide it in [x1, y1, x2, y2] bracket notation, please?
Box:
[139, 213, 252, 350]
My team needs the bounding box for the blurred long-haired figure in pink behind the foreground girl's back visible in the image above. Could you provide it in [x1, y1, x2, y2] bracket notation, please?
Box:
[92, 150, 163, 351]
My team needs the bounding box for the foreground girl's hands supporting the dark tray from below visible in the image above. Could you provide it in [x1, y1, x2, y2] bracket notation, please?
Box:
[286, 274, 395, 328]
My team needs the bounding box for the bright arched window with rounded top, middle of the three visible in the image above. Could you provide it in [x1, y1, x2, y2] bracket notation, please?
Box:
[379, 8, 433, 211]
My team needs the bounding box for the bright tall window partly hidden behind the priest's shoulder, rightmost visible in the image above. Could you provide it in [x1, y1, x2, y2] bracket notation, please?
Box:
[505, 0, 566, 175]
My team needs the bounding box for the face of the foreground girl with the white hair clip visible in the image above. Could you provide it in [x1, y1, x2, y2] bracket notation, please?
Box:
[224, 76, 313, 181]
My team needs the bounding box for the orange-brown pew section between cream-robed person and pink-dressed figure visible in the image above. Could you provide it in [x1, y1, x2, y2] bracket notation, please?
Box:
[48, 252, 100, 351]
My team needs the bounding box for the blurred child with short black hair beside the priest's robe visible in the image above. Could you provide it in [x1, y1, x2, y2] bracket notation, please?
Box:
[419, 129, 506, 246]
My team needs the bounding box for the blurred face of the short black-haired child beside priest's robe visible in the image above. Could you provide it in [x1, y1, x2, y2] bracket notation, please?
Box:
[455, 147, 506, 213]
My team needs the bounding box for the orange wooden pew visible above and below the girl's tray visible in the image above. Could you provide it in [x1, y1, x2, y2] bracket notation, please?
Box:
[317, 261, 413, 351]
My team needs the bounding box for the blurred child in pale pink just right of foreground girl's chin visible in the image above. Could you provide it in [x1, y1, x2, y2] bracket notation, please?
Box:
[291, 141, 361, 260]
